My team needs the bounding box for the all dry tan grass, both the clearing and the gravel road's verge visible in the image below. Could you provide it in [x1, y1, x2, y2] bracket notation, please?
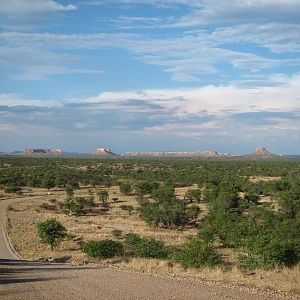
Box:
[6, 187, 300, 294]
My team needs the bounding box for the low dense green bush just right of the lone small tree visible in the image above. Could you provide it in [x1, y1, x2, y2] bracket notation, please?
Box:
[82, 240, 123, 259]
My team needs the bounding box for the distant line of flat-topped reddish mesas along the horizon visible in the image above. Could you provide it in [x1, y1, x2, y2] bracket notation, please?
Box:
[0, 147, 300, 160]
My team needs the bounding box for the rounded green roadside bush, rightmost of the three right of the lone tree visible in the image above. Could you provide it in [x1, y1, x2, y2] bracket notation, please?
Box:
[175, 238, 221, 268]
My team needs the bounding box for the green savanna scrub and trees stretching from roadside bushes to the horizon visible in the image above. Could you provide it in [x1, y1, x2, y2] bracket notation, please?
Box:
[0, 157, 300, 276]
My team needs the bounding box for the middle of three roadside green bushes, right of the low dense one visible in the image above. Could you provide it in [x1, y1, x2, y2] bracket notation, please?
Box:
[125, 233, 169, 259]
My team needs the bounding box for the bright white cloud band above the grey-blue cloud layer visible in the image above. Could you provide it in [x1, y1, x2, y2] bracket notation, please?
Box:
[0, 74, 300, 115]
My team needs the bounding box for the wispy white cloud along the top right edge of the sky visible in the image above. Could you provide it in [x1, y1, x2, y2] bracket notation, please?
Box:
[81, 0, 300, 27]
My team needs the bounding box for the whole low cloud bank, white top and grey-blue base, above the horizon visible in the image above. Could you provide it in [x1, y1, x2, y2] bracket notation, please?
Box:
[0, 75, 300, 152]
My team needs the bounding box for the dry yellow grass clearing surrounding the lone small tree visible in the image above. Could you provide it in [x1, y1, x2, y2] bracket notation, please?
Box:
[8, 187, 197, 262]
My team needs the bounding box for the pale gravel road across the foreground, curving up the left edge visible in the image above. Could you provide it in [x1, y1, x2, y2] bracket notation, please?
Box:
[0, 199, 300, 300]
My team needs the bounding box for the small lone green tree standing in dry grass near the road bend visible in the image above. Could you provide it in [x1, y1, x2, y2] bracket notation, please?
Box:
[37, 219, 67, 251]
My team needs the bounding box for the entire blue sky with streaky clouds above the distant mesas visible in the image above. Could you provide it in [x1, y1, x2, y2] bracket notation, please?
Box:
[0, 0, 300, 154]
